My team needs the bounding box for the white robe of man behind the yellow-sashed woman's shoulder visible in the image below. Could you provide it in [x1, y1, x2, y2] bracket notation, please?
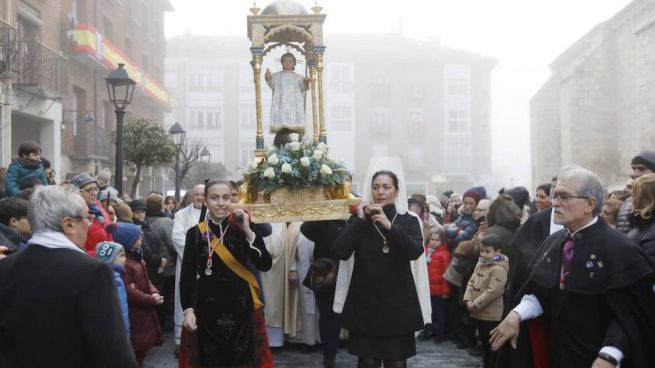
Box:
[172, 204, 200, 345]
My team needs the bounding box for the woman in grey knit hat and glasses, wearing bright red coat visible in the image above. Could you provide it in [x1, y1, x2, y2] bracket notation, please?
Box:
[70, 173, 113, 257]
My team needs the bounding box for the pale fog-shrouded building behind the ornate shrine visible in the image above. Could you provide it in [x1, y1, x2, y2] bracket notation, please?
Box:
[165, 34, 496, 193]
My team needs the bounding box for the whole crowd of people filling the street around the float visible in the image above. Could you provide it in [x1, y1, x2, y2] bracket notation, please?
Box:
[0, 141, 655, 368]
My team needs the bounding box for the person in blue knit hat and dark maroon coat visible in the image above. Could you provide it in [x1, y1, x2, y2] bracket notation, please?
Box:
[107, 222, 164, 366]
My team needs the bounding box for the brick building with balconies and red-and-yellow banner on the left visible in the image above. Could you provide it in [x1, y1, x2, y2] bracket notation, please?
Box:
[0, 0, 173, 197]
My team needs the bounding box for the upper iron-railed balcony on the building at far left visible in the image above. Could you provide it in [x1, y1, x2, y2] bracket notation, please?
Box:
[11, 40, 68, 99]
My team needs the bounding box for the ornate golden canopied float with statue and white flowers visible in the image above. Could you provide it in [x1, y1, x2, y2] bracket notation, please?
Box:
[233, 0, 361, 223]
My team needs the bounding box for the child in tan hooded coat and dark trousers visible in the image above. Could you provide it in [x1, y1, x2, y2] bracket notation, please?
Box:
[464, 234, 509, 367]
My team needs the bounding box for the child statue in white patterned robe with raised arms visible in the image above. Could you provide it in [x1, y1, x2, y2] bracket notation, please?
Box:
[264, 52, 310, 134]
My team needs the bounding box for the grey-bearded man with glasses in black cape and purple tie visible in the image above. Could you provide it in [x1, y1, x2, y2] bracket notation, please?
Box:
[490, 167, 655, 368]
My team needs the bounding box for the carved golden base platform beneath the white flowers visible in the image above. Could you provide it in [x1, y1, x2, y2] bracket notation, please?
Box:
[230, 188, 362, 224]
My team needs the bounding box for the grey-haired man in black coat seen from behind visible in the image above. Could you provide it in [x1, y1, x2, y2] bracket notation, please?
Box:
[0, 186, 137, 368]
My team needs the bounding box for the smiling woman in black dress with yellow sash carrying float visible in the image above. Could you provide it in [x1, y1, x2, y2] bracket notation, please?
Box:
[180, 181, 272, 367]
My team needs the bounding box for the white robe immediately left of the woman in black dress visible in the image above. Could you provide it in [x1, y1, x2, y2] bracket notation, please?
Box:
[298, 234, 321, 345]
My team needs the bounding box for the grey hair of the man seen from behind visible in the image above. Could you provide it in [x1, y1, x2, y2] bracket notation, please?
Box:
[27, 185, 86, 233]
